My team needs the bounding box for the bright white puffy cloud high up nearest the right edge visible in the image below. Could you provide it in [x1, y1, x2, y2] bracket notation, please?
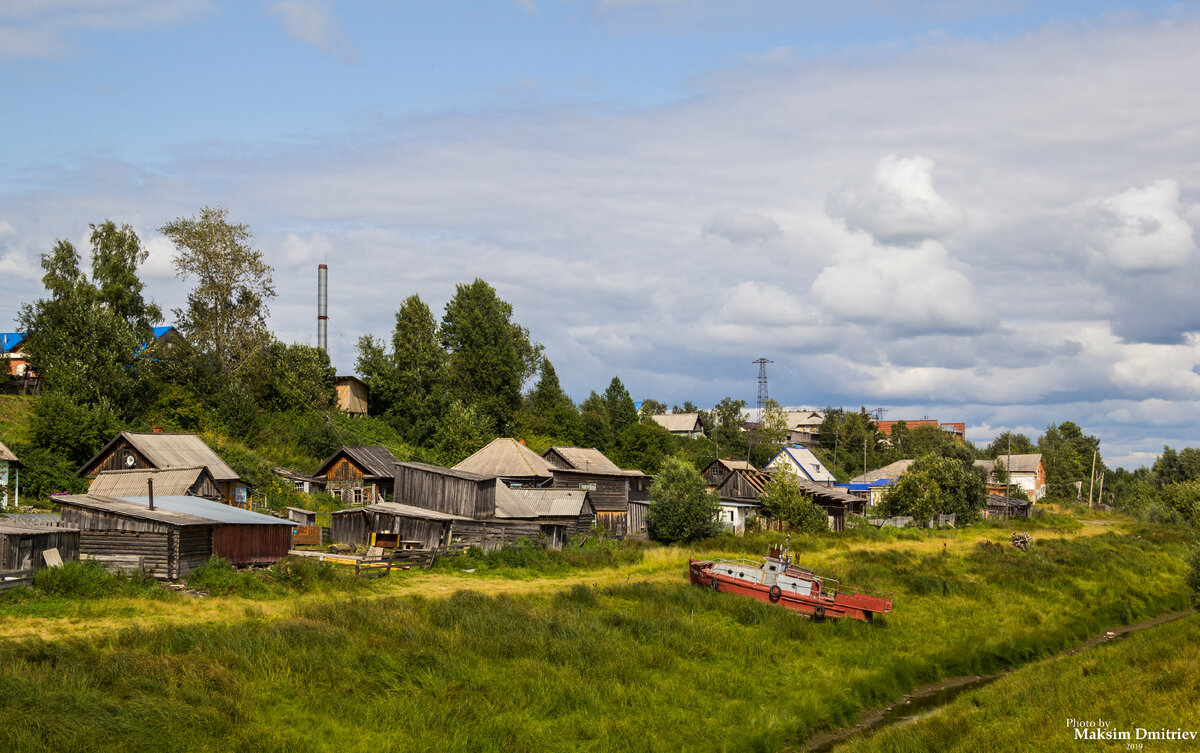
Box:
[1092, 180, 1196, 272]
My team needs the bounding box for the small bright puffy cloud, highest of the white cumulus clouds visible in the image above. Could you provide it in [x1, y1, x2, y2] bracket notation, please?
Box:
[830, 155, 966, 243]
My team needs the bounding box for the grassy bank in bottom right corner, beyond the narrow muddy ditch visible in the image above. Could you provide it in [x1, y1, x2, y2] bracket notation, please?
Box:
[834, 615, 1200, 753]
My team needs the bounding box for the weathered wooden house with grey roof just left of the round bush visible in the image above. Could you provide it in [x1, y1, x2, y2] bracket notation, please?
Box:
[542, 447, 648, 536]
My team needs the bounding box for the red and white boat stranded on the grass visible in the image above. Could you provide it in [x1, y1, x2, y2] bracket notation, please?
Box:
[688, 549, 892, 622]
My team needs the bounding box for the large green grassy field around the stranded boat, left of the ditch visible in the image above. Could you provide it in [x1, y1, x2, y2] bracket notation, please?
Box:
[0, 520, 1187, 753]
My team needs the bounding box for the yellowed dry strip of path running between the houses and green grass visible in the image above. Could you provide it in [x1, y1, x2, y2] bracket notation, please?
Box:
[0, 522, 1111, 639]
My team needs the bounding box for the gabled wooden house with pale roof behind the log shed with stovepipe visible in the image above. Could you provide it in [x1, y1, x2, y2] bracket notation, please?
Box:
[79, 429, 250, 507]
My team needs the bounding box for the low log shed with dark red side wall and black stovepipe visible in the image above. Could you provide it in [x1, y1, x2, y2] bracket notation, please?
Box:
[54, 494, 294, 580]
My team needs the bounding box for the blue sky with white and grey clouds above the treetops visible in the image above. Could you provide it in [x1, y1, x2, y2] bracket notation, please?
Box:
[0, 0, 1200, 465]
